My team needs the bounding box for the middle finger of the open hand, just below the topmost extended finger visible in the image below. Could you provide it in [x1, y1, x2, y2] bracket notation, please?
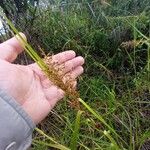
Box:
[58, 56, 84, 74]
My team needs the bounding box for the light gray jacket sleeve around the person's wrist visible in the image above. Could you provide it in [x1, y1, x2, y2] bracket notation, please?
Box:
[0, 90, 35, 150]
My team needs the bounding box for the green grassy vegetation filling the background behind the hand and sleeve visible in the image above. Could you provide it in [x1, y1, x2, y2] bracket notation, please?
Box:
[0, 0, 150, 150]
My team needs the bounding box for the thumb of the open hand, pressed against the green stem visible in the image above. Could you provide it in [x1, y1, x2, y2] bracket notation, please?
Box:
[0, 33, 26, 62]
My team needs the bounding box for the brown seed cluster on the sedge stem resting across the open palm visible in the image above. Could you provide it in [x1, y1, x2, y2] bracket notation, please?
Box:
[44, 56, 80, 109]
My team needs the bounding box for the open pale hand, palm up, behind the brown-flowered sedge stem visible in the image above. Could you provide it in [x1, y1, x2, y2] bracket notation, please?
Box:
[0, 34, 84, 124]
